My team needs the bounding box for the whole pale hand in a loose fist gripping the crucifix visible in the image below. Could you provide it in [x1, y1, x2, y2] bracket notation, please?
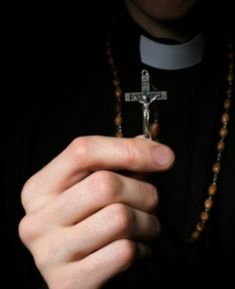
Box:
[19, 136, 174, 289]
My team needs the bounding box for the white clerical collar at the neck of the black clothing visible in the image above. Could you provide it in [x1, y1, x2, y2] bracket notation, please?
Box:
[140, 34, 204, 70]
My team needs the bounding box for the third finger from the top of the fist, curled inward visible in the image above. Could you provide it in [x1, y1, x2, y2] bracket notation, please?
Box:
[47, 204, 160, 262]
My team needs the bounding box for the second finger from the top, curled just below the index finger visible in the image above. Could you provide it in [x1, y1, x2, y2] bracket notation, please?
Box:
[46, 171, 158, 226]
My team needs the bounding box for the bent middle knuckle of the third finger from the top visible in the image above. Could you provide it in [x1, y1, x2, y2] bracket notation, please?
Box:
[111, 203, 134, 236]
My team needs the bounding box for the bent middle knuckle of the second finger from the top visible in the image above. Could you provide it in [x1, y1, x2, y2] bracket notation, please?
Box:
[91, 171, 122, 204]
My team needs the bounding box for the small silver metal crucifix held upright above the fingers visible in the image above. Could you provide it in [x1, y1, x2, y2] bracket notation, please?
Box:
[125, 69, 167, 139]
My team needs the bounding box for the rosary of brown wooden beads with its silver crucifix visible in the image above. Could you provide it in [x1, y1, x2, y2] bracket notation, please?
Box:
[106, 35, 235, 242]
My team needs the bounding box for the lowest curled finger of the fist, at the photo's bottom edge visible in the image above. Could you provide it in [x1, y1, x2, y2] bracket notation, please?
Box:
[42, 239, 151, 289]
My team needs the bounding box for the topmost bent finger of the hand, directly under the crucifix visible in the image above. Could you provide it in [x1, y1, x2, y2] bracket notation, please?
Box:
[22, 136, 174, 209]
